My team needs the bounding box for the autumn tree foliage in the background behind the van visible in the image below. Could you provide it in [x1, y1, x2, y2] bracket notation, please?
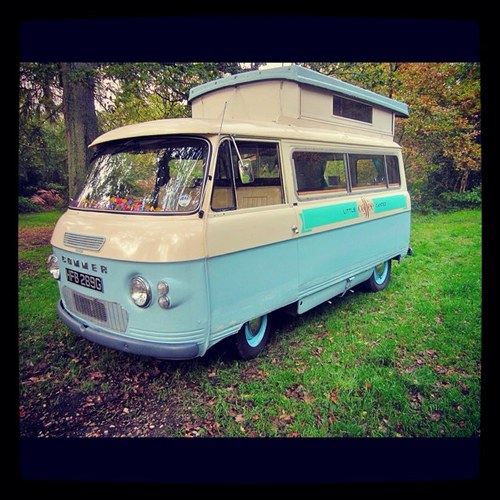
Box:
[19, 62, 481, 208]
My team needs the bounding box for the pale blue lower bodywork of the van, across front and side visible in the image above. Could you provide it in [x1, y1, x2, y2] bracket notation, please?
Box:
[54, 209, 411, 357]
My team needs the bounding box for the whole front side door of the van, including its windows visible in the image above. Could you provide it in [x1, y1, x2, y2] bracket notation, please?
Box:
[207, 138, 298, 343]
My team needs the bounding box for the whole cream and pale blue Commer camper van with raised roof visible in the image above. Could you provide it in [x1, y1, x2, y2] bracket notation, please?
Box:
[49, 66, 411, 359]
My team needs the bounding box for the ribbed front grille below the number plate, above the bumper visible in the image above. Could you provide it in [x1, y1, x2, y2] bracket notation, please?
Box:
[62, 286, 128, 332]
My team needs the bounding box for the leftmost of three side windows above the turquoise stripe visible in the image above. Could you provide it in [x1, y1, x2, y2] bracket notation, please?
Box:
[292, 151, 347, 196]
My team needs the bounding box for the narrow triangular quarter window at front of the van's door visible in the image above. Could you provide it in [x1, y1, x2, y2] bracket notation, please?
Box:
[211, 141, 236, 211]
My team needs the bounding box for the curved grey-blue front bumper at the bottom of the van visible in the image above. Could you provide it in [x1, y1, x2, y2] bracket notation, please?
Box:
[57, 300, 200, 360]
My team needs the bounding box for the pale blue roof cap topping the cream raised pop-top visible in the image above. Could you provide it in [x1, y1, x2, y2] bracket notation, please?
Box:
[189, 65, 408, 117]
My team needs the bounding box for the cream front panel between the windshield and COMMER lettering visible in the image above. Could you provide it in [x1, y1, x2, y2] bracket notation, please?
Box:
[51, 209, 206, 262]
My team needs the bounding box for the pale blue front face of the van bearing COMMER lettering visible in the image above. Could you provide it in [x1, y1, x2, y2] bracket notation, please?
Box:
[54, 248, 210, 355]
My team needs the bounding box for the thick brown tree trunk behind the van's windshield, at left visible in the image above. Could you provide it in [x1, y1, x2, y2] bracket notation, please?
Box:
[61, 63, 98, 198]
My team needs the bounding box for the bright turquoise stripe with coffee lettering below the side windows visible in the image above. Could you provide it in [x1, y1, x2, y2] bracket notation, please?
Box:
[300, 194, 407, 233]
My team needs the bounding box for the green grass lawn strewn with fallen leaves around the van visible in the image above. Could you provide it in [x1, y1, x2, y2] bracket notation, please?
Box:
[19, 210, 481, 437]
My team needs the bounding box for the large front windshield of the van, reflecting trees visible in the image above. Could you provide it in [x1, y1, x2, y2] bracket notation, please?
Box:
[71, 137, 209, 213]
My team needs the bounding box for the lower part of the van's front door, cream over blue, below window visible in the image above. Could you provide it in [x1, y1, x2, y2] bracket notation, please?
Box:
[206, 205, 298, 344]
